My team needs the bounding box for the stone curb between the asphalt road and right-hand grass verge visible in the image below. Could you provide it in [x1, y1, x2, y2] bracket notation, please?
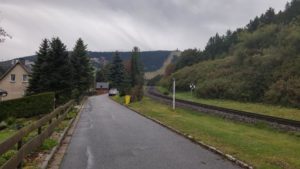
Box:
[111, 99, 253, 169]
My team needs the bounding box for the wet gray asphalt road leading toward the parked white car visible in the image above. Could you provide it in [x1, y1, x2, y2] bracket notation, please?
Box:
[61, 95, 239, 169]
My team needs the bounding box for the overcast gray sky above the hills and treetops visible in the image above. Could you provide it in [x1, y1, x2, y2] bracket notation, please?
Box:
[0, 0, 287, 61]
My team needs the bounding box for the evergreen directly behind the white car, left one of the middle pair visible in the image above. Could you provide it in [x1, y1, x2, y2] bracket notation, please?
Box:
[109, 51, 125, 91]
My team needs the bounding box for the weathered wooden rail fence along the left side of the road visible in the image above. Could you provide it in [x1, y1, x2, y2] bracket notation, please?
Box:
[0, 100, 74, 169]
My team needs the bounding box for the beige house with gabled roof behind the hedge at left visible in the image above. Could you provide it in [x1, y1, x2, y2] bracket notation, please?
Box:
[0, 61, 31, 100]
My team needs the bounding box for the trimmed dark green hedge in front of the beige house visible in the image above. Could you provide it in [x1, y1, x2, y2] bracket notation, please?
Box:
[0, 92, 55, 121]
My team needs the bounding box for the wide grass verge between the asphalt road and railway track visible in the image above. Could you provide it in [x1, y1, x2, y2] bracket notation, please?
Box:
[114, 97, 300, 169]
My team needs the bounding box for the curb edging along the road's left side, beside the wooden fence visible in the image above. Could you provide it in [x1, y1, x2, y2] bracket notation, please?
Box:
[40, 99, 87, 169]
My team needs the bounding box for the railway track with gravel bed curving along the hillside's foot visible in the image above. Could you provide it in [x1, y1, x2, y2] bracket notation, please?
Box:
[147, 87, 300, 130]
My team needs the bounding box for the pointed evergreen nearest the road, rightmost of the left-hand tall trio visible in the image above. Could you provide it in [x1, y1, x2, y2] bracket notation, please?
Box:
[70, 38, 92, 93]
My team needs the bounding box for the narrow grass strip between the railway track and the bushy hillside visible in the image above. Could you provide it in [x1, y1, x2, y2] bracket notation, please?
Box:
[157, 87, 300, 120]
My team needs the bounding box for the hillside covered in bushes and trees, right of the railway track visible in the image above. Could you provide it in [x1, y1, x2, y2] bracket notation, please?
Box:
[161, 0, 300, 107]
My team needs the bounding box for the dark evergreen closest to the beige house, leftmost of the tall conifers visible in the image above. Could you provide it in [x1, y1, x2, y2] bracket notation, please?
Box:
[27, 39, 49, 93]
